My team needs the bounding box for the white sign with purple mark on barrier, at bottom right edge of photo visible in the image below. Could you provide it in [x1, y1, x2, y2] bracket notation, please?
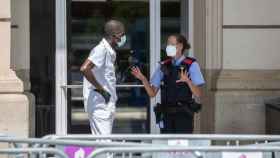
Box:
[222, 152, 263, 158]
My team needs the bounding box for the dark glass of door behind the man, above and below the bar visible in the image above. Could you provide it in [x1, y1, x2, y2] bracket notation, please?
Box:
[68, 1, 150, 133]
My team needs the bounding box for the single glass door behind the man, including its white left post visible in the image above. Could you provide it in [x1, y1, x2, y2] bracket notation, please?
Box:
[56, 0, 153, 134]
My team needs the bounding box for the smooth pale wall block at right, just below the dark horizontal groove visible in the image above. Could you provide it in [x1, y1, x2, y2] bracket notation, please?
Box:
[223, 29, 280, 70]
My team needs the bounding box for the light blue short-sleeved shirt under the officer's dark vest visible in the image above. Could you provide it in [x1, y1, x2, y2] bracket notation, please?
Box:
[151, 55, 205, 88]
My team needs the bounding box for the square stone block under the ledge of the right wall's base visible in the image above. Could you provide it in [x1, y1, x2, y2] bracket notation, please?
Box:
[215, 91, 280, 134]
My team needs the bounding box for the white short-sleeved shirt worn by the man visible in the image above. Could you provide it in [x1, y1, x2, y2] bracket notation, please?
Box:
[83, 39, 118, 104]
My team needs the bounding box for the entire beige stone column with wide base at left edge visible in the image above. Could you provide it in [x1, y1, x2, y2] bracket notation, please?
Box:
[0, 0, 35, 137]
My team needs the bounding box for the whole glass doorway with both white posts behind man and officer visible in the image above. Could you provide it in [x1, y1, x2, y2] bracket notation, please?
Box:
[56, 0, 188, 135]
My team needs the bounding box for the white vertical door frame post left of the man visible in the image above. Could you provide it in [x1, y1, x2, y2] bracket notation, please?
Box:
[55, 0, 68, 135]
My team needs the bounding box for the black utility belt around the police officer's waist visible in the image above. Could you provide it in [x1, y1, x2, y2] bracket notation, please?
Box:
[154, 100, 201, 123]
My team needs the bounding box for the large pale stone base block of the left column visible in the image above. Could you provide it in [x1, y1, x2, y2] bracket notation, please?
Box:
[0, 93, 35, 137]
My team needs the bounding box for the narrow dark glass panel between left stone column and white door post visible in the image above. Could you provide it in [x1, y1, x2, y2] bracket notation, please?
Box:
[30, 0, 55, 137]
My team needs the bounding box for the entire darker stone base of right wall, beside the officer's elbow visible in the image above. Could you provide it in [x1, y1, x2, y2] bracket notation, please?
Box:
[200, 70, 280, 134]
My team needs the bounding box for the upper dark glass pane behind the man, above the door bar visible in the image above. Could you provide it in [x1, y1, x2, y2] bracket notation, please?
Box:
[68, 1, 149, 84]
